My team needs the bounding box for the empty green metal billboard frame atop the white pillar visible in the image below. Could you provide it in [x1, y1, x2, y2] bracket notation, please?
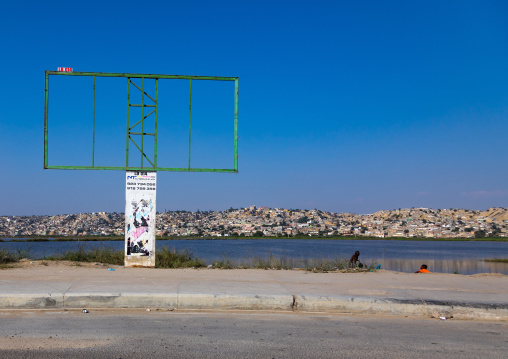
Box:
[44, 71, 238, 173]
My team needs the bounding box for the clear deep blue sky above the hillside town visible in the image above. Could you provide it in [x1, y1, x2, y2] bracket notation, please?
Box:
[0, 0, 508, 215]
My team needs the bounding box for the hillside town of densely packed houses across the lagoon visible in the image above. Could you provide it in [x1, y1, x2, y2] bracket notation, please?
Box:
[0, 206, 508, 238]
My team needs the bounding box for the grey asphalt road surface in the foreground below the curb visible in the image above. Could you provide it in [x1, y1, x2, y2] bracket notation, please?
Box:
[0, 310, 508, 359]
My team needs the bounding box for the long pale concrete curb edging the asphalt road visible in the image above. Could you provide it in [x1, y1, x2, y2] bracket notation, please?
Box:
[0, 292, 508, 321]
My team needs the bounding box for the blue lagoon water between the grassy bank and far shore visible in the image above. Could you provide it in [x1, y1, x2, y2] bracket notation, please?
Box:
[0, 239, 508, 275]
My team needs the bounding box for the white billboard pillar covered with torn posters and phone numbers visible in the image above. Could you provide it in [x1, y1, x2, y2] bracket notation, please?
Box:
[125, 171, 157, 267]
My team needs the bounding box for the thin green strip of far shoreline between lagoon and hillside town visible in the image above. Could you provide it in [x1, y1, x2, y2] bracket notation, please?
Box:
[0, 236, 508, 242]
